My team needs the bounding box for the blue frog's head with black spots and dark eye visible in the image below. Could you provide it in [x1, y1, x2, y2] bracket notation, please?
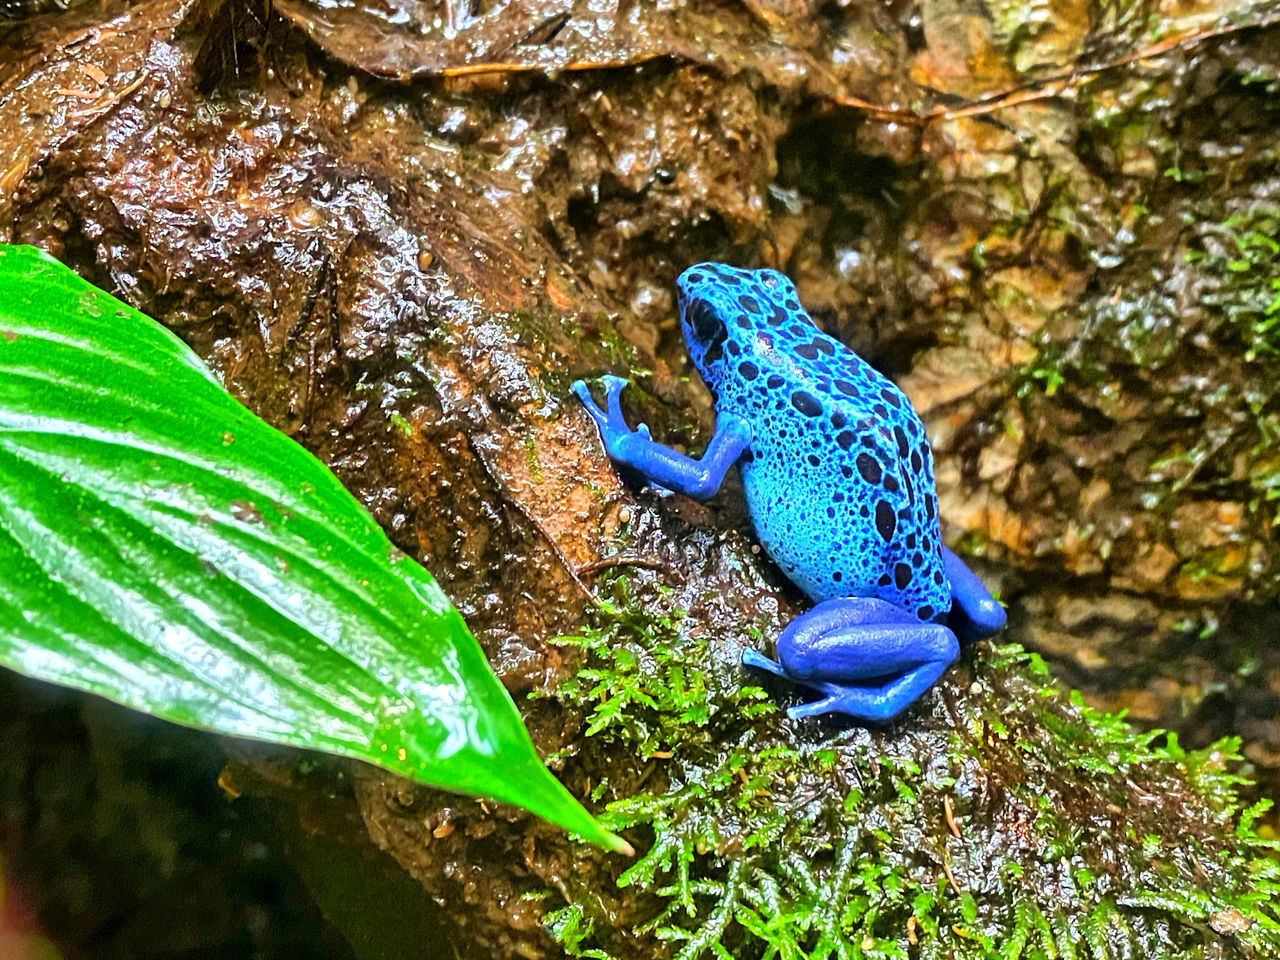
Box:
[676, 262, 800, 390]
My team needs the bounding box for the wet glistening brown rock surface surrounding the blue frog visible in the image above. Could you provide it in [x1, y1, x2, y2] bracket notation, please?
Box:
[0, 0, 1280, 956]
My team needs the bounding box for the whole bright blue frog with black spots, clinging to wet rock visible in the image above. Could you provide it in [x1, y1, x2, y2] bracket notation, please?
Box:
[572, 264, 1005, 722]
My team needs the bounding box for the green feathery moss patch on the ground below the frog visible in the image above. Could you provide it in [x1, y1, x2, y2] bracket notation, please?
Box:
[547, 578, 1280, 960]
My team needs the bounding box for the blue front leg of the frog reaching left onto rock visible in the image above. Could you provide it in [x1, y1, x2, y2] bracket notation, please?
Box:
[571, 376, 751, 499]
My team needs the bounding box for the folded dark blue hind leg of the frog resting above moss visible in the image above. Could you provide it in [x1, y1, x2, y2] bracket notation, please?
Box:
[742, 596, 960, 723]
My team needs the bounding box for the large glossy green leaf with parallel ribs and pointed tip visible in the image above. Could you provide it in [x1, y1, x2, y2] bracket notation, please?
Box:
[0, 246, 627, 850]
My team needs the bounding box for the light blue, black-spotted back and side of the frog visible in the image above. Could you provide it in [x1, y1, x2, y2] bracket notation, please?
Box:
[680, 268, 951, 620]
